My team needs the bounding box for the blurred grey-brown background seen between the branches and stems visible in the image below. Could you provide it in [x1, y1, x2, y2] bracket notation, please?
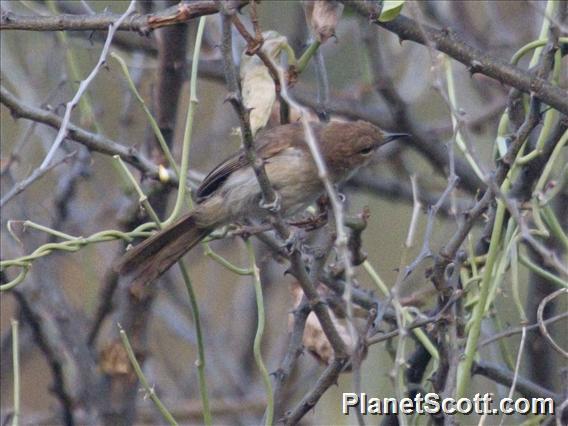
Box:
[0, 0, 568, 424]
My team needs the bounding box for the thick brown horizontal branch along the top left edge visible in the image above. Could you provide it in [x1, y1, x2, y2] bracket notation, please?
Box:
[0, 0, 248, 34]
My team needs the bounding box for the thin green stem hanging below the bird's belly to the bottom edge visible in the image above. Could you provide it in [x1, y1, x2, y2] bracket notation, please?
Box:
[246, 239, 274, 426]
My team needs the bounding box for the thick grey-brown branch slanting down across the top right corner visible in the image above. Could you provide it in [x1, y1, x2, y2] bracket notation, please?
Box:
[344, 1, 568, 114]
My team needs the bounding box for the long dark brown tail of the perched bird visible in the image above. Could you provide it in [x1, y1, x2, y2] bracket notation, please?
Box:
[115, 213, 211, 284]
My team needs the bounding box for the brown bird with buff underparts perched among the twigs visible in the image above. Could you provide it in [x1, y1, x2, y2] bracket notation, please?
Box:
[117, 121, 408, 284]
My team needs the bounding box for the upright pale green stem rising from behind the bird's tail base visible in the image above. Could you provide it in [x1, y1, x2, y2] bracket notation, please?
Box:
[164, 16, 206, 226]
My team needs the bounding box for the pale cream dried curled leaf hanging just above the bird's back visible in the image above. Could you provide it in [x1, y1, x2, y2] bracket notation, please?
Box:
[240, 31, 288, 135]
